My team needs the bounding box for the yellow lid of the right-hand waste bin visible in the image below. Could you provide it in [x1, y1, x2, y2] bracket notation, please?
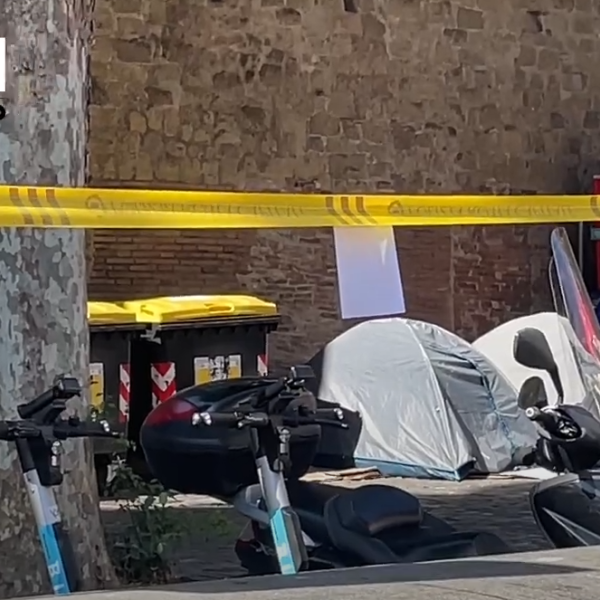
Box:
[121, 296, 277, 324]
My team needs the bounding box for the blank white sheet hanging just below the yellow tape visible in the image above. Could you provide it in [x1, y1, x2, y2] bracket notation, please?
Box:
[333, 227, 406, 319]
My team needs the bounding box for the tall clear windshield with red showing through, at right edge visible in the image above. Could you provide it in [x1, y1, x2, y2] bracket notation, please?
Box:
[550, 227, 600, 418]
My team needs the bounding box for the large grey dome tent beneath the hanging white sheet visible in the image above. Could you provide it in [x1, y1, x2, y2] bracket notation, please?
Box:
[311, 318, 537, 479]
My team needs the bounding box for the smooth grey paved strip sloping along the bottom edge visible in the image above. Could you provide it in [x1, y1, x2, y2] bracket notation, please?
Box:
[42, 548, 600, 600]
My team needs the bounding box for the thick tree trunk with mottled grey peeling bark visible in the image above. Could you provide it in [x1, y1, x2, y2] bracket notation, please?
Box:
[0, 0, 114, 597]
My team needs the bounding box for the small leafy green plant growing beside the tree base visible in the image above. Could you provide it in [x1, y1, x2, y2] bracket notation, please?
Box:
[109, 462, 183, 584]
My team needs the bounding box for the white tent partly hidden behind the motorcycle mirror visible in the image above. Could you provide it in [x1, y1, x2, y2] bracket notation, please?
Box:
[473, 312, 600, 415]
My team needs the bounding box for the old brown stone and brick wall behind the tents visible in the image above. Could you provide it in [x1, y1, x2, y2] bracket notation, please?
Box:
[89, 0, 600, 361]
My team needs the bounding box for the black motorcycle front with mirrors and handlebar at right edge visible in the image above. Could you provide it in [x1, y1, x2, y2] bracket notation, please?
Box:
[514, 328, 600, 548]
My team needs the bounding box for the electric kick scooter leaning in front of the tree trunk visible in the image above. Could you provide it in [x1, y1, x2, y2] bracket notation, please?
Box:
[0, 377, 119, 596]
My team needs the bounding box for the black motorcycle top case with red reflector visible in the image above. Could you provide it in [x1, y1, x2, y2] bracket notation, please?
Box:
[140, 377, 321, 498]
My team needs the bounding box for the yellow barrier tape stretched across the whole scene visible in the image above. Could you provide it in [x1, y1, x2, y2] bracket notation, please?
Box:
[0, 186, 600, 229]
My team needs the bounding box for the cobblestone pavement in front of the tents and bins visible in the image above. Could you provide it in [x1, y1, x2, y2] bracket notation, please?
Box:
[102, 477, 549, 580]
